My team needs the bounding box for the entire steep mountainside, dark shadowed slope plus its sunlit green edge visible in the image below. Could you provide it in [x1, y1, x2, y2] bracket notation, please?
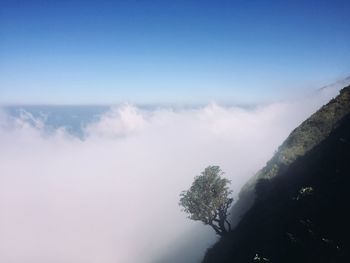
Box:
[204, 86, 350, 263]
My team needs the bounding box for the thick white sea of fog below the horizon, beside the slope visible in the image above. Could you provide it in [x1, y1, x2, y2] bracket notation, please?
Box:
[0, 84, 344, 263]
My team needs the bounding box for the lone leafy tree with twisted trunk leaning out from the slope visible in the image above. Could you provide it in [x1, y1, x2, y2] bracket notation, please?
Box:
[179, 166, 233, 236]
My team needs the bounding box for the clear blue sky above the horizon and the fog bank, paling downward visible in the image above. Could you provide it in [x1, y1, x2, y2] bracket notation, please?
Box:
[0, 0, 350, 104]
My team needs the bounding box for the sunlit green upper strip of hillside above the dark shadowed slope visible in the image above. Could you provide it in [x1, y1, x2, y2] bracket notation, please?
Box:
[231, 85, 350, 228]
